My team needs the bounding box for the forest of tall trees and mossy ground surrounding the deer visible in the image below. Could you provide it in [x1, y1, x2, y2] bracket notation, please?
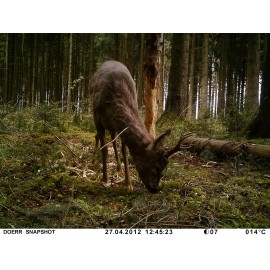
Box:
[0, 33, 270, 228]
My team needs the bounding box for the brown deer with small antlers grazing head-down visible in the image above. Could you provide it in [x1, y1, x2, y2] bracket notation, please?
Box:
[91, 61, 179, 193]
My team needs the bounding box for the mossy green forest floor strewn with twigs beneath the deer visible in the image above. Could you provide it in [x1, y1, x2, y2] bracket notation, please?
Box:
[0, 108, 270, 228]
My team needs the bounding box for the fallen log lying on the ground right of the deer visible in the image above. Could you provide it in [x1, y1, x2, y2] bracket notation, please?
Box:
[178, 133, 270, 159]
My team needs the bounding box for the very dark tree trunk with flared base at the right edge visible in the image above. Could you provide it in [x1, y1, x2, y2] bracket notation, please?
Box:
[248, 34, 270, 138]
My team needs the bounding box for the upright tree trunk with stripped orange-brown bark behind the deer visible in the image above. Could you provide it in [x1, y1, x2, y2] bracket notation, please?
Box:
[145, 34, 162, 137]
